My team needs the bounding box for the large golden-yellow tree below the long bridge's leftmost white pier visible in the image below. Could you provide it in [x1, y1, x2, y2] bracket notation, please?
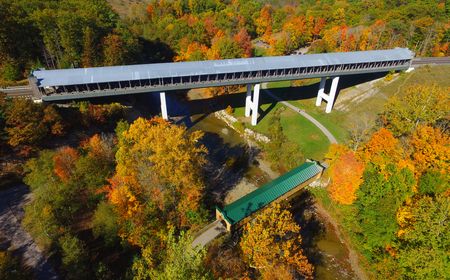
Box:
[116, 117, 207, 225]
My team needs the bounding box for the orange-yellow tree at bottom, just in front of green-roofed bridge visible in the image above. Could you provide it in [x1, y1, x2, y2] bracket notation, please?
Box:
[239, 204, 313, 279]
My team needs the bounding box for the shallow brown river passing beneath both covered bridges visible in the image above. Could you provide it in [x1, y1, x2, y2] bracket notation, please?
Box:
[134, 91, 357, 280]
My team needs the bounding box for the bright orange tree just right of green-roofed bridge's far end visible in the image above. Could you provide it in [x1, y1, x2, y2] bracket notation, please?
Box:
[328, 151, 365, 205]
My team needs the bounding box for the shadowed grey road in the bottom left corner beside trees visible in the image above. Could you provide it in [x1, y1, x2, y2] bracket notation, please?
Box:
[0, 185, 59, 280]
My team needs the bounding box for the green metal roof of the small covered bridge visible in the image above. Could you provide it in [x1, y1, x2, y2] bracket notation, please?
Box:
[220, 162, 323, 224]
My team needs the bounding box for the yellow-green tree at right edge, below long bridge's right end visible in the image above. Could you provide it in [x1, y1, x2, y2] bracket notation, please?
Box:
[384, 84, 450, 136]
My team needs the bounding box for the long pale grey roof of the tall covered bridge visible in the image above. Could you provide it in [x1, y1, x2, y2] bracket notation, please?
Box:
[32, 48, 413, 87]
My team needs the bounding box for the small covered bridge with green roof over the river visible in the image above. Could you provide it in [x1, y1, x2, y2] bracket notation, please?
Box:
[216, 160, 325, 231]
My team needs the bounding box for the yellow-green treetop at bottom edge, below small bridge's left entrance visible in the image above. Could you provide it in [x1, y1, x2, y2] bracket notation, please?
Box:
[133, 229, 211, 280]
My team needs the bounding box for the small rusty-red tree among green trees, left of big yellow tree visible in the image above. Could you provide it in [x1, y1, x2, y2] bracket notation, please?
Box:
[53, 147, 80, 182]
